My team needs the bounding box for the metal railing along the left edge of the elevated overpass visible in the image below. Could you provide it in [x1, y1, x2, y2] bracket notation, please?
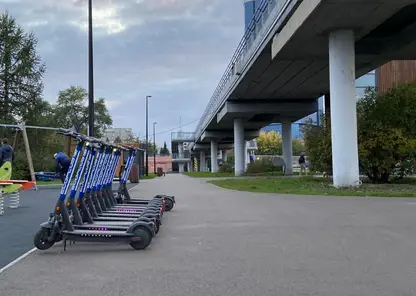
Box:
[195, 0, 292, 140]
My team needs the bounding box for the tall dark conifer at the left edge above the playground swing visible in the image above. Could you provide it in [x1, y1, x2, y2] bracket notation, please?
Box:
[0, 12, 45, 123]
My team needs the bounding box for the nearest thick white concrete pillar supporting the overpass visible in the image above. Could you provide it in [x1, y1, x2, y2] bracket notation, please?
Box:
[329, 30, 359, 187]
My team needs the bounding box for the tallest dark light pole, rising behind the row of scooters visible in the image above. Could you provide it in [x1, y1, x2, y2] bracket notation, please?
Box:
[88, 0, 94, 137]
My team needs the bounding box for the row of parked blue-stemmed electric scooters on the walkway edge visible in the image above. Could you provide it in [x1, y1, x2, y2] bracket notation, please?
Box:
[34, 130, 175, 250]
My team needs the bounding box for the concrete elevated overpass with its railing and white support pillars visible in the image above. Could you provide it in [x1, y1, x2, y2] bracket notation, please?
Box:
[193, 0, 416, 186]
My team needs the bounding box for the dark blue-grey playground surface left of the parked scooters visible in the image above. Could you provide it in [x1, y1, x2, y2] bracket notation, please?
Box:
[0, 184, 135, 268]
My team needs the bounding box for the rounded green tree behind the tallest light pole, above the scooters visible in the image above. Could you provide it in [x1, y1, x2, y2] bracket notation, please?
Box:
[54, 86, 113, 137]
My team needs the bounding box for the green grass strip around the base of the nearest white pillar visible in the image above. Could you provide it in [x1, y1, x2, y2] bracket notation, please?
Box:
[209, 177, 416, 197]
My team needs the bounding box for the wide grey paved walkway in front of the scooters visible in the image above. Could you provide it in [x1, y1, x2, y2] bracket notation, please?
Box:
[0, 175, 416, 296]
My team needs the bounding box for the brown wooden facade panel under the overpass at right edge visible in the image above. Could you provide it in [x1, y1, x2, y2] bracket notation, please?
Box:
[376, 60, 416, 93]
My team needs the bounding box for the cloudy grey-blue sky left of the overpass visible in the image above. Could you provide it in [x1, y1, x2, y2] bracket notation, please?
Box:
[0, 0, 244, 145]
